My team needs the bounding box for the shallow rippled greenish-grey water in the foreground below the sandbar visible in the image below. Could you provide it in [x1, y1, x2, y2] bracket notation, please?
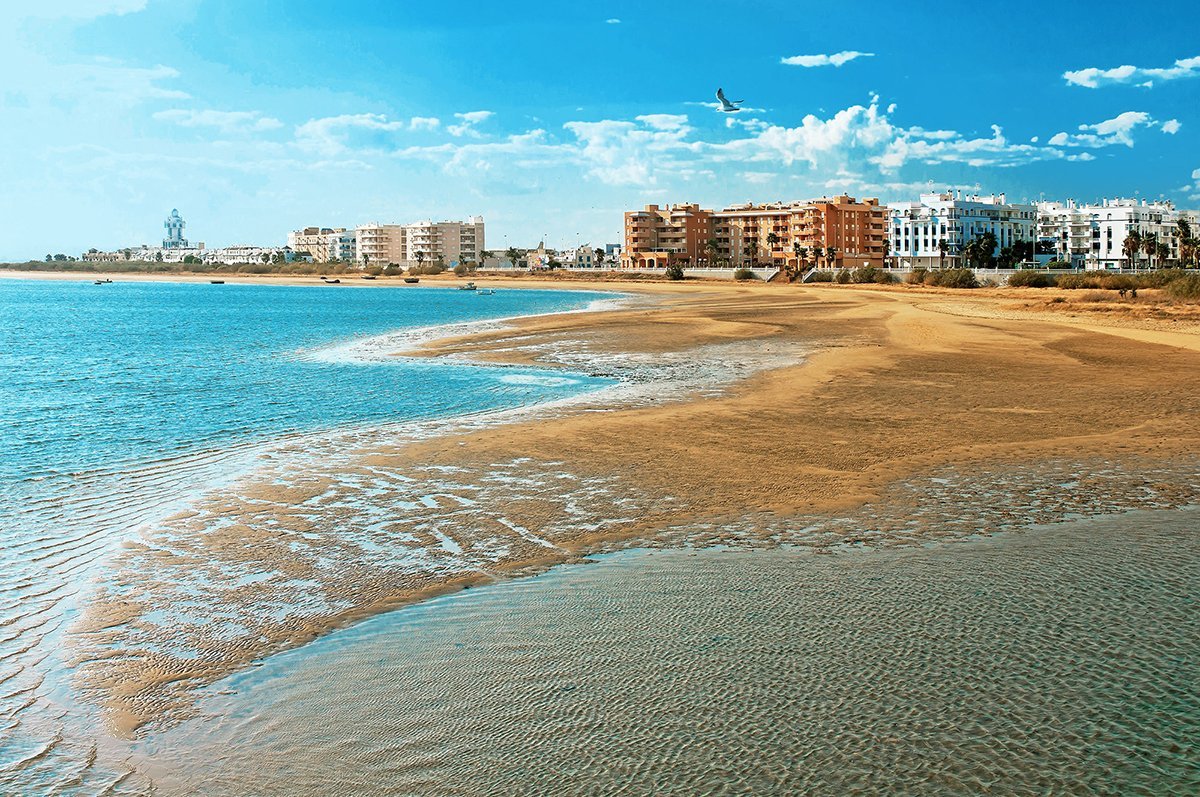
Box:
[131, 509, 1200, 795]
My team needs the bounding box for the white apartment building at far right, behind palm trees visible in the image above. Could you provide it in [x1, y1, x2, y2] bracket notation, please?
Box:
[1038, 198, 1200, 269]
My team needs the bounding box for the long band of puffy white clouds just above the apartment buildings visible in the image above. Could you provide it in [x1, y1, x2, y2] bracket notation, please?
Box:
[283, 95, 1174, 195]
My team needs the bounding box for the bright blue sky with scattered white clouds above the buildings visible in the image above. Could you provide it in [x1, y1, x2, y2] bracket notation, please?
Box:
[0, 0, 1200, 259]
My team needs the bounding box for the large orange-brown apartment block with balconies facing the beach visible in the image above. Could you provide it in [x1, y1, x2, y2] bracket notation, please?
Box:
[622, 196, 887, 268]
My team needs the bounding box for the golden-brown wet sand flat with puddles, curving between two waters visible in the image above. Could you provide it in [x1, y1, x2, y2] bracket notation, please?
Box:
[68, 283, 1200, 732]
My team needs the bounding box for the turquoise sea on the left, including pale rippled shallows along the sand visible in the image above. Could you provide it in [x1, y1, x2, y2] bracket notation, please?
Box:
[0, 280, 608, 793]
